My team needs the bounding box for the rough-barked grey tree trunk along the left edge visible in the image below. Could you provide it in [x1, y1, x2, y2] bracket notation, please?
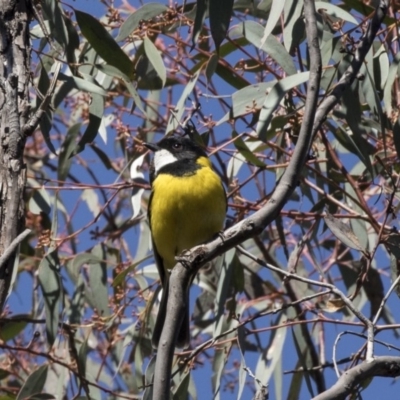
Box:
[0, 0, 30, 312]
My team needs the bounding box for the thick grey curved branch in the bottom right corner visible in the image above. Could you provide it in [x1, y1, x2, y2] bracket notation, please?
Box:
[313, 356, 400, 400]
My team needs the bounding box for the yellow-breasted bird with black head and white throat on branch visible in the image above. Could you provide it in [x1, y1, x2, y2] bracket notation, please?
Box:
[145, 136, 227, 348]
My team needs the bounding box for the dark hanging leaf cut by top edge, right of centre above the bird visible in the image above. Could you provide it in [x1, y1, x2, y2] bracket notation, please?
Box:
[208, 0, 233, 52]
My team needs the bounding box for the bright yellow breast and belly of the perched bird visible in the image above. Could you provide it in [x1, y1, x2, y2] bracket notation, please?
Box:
[150, 157, 226, 269]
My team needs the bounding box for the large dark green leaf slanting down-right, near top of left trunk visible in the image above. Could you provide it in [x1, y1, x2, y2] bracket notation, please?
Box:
[75, 10, 134, 79]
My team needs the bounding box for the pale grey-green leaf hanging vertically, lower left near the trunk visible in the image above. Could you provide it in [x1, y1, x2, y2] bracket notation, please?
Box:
[39, 251, 63, 346]
